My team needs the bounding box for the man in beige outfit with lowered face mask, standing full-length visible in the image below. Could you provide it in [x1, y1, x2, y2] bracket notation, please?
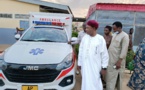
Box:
[106, 21, 129, 90]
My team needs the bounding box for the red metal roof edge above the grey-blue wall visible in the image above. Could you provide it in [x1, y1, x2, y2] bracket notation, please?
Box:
[87, 3, 145, 18]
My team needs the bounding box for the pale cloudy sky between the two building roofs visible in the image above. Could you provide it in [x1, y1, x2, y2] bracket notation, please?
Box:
[43, 0, 145, 17]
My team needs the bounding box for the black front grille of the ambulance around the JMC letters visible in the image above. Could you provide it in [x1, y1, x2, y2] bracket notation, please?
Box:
[3, 64, 61, 83]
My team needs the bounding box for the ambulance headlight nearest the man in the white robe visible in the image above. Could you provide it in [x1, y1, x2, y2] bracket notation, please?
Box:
[56, 54, 73, 70]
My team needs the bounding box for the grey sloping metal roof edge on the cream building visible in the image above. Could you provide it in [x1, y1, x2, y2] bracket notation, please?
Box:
[18, 0, 73, 14]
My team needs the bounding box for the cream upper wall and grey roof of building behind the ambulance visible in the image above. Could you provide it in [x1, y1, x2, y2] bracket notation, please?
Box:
[0, 0, 72, 29]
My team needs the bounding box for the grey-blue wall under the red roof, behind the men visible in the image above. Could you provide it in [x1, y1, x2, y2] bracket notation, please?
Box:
[88, 10, 145, 46]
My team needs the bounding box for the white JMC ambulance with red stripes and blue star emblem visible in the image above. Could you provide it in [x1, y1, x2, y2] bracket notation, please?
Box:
[0, 13, 75, 90]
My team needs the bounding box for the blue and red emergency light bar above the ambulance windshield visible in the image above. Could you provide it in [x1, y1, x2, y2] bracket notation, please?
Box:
[33, 21, 65, 26]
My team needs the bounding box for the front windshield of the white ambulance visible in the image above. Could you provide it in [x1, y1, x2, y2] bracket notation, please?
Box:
[21, 27, 68, 43]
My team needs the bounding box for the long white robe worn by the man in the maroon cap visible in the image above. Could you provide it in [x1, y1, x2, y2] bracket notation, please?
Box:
[78, 34, 109, 90]
